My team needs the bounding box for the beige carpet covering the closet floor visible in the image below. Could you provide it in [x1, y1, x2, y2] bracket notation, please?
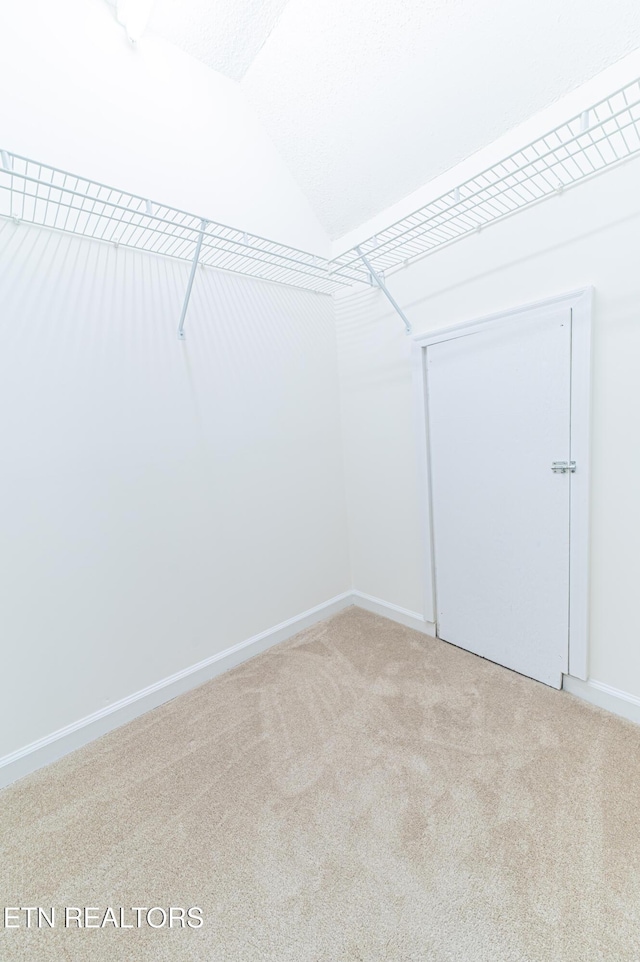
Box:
[0, 608, 640, 962]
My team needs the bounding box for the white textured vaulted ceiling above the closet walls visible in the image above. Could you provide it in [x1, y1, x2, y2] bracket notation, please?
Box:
[130, 0, 640, 238]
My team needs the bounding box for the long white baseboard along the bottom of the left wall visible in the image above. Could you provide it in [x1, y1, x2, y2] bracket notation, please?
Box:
[0, 591, 355, 789]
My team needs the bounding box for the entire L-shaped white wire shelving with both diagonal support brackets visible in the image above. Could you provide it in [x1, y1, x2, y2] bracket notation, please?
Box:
[0, 79, 640, 336]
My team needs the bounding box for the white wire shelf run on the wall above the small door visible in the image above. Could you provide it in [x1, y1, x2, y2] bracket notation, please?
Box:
[331, 79, 640, 281]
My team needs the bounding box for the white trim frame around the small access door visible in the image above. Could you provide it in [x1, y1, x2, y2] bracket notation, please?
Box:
[412, 287, 593, 680]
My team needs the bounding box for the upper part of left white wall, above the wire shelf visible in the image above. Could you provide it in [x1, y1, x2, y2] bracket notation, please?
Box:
[0, 0, 328, 256]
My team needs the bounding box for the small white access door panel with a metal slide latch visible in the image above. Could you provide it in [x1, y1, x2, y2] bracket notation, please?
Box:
[427, 308, 571, 688]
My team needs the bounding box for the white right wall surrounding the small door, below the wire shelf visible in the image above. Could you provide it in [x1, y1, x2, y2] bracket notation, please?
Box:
[338, 152, 640, 697]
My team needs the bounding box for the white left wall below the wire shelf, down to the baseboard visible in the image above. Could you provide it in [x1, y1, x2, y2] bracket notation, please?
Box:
[0, 222, 350, 757]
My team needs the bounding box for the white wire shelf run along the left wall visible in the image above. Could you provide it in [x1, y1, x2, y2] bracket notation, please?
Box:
[0, 150, 352, 294]
